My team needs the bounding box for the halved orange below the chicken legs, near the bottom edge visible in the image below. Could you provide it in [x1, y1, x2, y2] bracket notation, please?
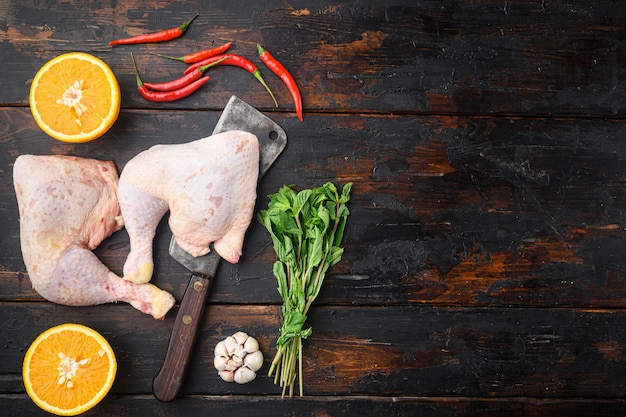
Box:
[22, 323, 117, 416]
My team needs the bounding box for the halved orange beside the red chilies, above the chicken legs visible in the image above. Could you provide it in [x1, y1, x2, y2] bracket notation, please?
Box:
[29, 52, 121, 143]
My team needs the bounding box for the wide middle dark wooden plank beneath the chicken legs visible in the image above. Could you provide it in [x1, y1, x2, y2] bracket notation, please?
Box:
[0, 108, 626, 308]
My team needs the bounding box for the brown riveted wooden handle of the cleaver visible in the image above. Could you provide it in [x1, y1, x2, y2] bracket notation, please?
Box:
[152, 275, 213, 401]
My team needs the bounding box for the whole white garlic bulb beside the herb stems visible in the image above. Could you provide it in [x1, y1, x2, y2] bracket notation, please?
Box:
[213, 332, 263, 384]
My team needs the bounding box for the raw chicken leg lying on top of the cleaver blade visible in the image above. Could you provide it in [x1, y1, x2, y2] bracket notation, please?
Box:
[119, 131, 259, 283]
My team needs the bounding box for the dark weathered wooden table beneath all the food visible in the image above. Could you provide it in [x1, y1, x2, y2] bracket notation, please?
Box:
[0, 0, 626, 417]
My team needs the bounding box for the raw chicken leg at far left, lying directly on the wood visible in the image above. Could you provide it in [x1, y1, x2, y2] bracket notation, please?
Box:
[13, 155, 174, 318]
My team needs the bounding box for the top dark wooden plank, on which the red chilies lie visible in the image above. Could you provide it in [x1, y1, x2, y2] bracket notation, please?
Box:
[0, 0, 626, 117]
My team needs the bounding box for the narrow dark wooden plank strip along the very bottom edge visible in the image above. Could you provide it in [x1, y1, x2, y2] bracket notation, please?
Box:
[0, 395, 626, 417]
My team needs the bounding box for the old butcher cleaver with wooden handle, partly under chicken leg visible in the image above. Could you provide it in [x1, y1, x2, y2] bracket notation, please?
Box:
[152, 96, 287, 401]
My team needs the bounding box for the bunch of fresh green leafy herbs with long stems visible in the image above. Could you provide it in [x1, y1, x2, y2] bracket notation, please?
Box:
[259, 182, 352, 396]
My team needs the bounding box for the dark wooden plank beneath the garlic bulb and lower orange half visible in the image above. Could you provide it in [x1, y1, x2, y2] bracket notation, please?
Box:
[0, 303, 626, 399]
